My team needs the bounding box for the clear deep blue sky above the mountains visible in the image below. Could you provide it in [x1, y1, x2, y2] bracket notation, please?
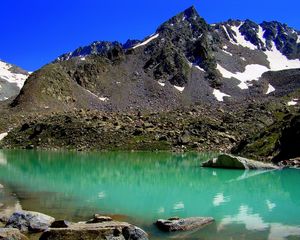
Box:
[0, 0, 300, 71]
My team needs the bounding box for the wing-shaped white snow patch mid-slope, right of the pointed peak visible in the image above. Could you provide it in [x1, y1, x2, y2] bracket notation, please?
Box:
[217, 64, 269, 89]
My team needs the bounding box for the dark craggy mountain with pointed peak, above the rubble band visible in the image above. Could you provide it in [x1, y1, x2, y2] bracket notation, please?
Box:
[12, 7, 300, 111]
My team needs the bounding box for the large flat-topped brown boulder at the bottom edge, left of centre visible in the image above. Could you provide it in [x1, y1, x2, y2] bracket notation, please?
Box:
[40, 221, 148, 240]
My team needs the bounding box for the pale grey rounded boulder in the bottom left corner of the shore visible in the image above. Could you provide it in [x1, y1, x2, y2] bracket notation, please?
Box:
[6, 210, 55, 232]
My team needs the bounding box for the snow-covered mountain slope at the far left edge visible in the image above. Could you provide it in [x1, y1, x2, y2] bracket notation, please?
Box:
[0, 60, 29, 101]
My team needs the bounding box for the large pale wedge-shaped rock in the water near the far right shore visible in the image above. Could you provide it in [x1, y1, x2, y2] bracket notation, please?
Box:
[202, 154, 279, 169]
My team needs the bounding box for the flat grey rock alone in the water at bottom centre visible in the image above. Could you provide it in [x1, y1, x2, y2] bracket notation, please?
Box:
[155, 217, 214, 232]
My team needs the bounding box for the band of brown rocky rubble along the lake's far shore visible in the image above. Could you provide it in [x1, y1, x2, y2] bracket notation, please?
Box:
[0, 100, 296, 158]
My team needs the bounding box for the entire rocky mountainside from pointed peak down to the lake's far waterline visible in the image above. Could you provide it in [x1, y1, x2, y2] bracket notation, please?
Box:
[0, 7, 300, 162]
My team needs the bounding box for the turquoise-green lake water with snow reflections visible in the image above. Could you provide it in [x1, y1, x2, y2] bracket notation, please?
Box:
[0, 151, 300, 240]
